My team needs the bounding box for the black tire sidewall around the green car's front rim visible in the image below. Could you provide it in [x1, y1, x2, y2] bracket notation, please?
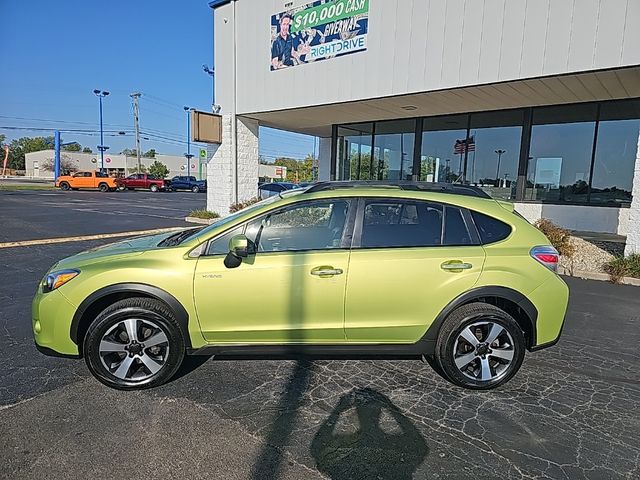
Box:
[83, 307, 185, 390]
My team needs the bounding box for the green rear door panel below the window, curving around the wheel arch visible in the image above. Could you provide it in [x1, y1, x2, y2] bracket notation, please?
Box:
[345, 246, 485, 343]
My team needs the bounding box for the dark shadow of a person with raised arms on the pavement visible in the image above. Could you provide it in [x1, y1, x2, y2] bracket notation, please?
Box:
[311, 388, 429, 480]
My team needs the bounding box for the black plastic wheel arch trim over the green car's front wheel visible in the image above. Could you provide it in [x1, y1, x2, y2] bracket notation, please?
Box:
[69, 283, 191, 348]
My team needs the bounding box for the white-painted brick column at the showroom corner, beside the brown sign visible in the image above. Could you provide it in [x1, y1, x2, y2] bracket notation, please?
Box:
[207, 115, 258, 217]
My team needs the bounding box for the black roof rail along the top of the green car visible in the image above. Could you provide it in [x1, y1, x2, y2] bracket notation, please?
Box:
[305, 180, 491, 198]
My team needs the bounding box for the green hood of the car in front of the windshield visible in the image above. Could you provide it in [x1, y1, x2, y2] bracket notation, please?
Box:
[52, 231, 182, 270]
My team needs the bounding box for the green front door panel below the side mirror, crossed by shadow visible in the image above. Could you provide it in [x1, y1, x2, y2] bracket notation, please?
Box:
[194, 250, 349, 344]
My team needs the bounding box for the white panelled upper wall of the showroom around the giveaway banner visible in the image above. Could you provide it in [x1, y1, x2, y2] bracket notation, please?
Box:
[215, 0, 640, 114]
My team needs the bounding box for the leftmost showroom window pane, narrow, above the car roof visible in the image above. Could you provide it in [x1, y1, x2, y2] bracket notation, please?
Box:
[337, 123, 377, 180]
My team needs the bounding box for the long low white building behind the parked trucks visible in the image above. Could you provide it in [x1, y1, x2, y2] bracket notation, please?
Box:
[25, 150, 207, 179]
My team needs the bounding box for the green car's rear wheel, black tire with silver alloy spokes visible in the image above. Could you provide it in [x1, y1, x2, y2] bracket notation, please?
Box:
[435, 302, 525, 390]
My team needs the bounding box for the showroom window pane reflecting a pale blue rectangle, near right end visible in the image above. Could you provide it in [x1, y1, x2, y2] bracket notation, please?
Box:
[525, 104, 597, 203]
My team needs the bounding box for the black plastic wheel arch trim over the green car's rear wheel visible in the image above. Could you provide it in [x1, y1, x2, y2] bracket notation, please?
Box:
[419, 286, 538, 350]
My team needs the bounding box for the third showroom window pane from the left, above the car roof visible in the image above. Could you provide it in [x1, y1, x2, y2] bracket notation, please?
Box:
[420, 115, 469, 183]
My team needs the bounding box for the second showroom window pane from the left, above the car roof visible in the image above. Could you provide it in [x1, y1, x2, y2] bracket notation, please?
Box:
[374, 120, 416, 180]
